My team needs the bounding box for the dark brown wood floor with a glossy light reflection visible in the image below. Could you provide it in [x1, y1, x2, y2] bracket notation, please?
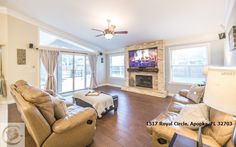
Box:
[8, 86, 171, 147]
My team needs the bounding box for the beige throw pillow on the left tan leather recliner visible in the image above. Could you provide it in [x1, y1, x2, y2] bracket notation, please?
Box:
[52, 97, 67, 120]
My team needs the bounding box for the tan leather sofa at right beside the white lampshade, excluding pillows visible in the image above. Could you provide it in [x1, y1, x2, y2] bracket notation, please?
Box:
[147, 90, 234, 147]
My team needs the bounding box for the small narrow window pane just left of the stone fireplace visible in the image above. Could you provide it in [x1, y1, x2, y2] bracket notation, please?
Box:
[110, 55, 124, 78]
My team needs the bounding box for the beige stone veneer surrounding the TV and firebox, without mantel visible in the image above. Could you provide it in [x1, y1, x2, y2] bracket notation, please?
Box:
[122, 40, 167, 98]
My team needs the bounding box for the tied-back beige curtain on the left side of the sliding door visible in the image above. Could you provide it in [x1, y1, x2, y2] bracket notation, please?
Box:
[40, 50, 59, 92]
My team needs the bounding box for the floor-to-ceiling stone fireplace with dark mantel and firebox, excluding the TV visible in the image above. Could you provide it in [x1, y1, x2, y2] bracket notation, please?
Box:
[122, 40, 167, 98]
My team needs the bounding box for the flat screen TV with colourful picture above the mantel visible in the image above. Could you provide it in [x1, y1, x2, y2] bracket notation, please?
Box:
[129, 48, 157, 68]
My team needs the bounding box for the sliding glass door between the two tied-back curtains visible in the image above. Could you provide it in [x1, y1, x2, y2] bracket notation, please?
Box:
[57, 53, 90, 93]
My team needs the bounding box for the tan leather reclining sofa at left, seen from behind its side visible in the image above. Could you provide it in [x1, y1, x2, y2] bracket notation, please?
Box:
[11, 81, 97, 147]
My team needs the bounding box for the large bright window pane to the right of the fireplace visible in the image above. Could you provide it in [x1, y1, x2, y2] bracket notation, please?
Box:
[169, 44, 209, 84]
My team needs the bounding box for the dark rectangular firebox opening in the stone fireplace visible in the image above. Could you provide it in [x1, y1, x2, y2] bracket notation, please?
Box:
[135, 75, 152, 88]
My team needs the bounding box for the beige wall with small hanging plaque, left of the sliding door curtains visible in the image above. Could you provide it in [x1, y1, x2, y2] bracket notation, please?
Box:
[3, 16, 39, 101]
